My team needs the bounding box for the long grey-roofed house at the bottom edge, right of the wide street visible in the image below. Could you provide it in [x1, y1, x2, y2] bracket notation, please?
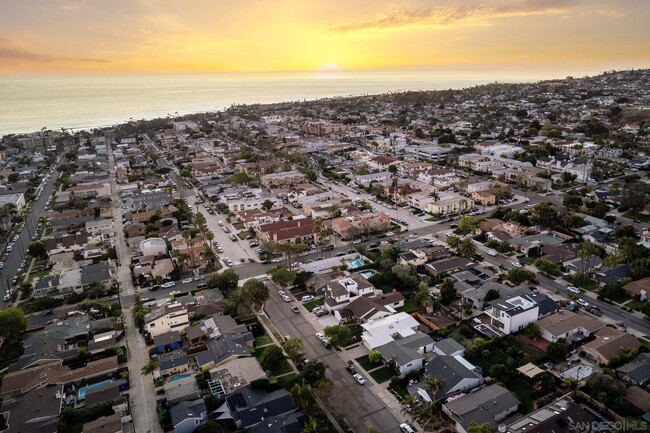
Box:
[442, 383, 520, 433]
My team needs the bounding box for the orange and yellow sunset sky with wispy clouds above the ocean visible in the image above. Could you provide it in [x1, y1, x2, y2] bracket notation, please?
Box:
[0, 0, 650, 73]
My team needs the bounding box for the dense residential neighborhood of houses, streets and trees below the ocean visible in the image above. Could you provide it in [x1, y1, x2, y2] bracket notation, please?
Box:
[0, 70, 650, 433]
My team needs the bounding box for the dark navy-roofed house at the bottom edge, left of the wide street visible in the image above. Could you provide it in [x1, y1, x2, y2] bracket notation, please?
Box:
[214, 386, 302, 432]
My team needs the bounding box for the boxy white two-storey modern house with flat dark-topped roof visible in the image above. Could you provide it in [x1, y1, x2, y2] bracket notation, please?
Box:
[486, 294, 539, 335]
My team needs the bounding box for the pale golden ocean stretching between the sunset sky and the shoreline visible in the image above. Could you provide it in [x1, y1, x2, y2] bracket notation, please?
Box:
[0, 70, 551, 136]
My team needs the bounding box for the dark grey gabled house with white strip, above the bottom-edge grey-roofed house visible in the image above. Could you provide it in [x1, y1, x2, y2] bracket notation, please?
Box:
[424, 354, 483, 401]
